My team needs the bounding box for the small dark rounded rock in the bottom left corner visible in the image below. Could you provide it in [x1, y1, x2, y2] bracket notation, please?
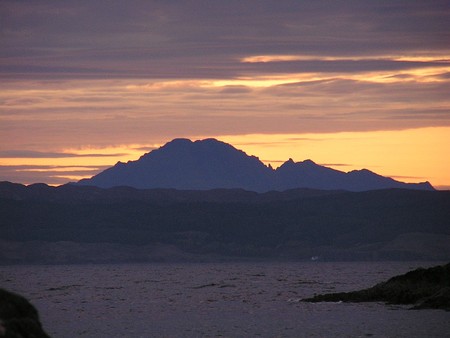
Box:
[0, 289, 49, 338]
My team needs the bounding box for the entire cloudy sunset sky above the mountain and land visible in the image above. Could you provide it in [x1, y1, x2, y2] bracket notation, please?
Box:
[0, 0, 450, 189]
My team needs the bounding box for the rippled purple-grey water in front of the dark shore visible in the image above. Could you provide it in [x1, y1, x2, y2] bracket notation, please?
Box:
[0, 262, 450, 337]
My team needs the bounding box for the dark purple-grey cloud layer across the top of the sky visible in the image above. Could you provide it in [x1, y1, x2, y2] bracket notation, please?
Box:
[0, 0, 450, 78]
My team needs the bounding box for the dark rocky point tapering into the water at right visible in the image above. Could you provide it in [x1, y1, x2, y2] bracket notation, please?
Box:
[303, 263, 450, 311]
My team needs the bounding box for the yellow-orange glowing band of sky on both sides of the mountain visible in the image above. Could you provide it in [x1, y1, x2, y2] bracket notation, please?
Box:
[0, 127, 450, 189]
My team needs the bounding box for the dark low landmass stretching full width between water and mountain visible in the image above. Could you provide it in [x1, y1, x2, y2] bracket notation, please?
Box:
[0, 182, 450, 264]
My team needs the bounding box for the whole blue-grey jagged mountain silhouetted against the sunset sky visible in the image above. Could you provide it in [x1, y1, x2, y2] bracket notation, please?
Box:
[77, 139, 433, 192]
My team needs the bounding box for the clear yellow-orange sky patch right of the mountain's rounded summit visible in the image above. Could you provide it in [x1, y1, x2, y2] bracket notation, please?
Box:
[214, 127, 450, 187]
